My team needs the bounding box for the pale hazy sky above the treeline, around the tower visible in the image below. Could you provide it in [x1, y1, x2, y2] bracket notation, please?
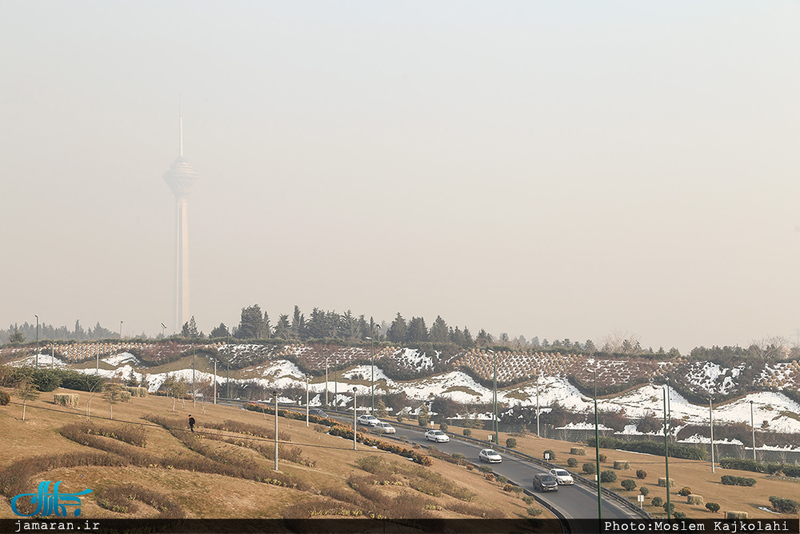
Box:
[0, 0, 800, 351]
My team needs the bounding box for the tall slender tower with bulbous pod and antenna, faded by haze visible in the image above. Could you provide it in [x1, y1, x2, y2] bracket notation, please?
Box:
[164, 102, 198, 332]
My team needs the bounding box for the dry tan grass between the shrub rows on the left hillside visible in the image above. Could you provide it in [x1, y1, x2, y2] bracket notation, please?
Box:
[0, 390, 552, 518]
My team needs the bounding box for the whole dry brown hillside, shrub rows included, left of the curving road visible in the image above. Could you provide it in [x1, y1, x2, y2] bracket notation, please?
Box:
[0, 390, 548, 519]
